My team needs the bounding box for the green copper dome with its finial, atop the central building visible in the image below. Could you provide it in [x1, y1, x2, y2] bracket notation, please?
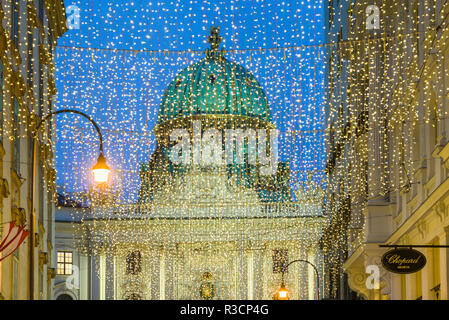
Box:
[157, 28, 271, 124]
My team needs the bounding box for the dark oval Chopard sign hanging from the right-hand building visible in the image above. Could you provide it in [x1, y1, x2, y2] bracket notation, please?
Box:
[382, 249, 426, 274]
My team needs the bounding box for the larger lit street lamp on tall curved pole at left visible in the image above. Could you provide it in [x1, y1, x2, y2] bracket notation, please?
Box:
[30, 109, 111, 300]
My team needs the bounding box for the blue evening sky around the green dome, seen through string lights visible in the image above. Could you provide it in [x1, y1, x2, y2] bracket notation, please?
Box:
[55, 0, 326, 199]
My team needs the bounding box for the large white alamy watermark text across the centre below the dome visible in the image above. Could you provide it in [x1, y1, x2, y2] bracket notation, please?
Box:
[169, 121, 279, 175]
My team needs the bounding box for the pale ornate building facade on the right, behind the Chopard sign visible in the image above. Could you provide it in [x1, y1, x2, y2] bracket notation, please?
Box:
[325, 0, 449, 300]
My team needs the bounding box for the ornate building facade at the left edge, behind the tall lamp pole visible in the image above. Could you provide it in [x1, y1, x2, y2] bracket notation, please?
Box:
[0, 0, 67, 300]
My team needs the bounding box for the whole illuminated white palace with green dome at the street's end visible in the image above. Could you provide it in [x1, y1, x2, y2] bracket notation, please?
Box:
[55, 29, 324, 299]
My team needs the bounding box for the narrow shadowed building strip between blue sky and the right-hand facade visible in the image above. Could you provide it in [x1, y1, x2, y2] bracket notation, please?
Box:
[321, 1, 355, 300]
